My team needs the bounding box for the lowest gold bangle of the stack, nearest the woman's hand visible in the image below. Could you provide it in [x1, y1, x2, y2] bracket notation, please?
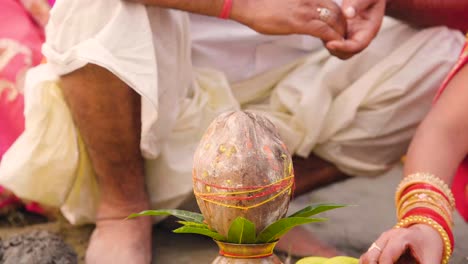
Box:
[395, 215, 452, 264]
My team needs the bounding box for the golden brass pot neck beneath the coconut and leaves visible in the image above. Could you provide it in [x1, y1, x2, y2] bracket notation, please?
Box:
[212, 240, 283, 264]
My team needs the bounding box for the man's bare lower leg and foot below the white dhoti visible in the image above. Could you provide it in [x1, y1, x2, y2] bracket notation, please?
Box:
[61, 65, 152, 264]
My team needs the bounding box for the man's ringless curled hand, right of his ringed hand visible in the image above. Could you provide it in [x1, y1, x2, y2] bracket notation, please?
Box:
[326, 0, 387, 59]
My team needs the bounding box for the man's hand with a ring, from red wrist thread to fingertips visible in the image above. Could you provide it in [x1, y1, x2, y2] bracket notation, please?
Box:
[231, 0, 347, 43]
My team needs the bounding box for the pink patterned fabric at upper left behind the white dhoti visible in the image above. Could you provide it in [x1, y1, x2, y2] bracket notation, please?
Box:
[0, 0, 44, 160]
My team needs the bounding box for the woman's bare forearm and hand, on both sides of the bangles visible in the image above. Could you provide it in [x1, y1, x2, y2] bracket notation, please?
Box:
[361, 58, 468, 264]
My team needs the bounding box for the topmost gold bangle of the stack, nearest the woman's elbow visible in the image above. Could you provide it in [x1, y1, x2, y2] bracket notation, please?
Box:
[395, 173, 455, 208]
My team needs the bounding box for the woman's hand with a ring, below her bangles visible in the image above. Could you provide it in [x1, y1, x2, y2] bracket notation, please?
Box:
[359, 224, 444, 264]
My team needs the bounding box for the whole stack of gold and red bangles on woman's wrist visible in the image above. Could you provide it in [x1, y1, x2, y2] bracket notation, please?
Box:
[395, 173, 455, 264]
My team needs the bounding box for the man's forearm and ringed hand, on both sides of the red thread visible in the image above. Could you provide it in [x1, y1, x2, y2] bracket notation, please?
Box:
[124, 0, 347, 55]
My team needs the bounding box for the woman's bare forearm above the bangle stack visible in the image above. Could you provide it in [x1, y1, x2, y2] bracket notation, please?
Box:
[405, 65, 468, 183]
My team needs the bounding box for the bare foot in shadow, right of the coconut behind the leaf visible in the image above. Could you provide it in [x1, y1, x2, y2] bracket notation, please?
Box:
[276, 226, 343, 258]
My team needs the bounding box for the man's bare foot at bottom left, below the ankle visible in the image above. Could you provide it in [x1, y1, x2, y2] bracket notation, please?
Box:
[86, 201, 153, 264]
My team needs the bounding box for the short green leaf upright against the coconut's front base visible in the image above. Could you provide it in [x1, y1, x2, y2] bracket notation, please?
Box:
[227, 217, 256, 244]
